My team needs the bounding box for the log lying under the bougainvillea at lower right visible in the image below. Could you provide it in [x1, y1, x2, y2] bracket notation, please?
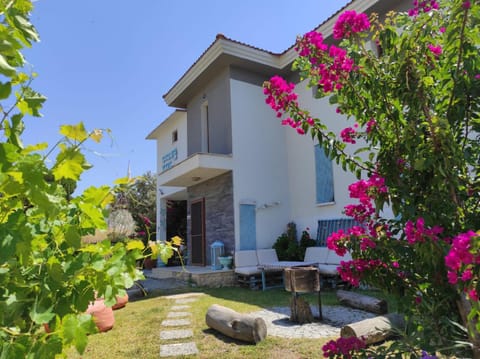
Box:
[340, 313, 405, 345]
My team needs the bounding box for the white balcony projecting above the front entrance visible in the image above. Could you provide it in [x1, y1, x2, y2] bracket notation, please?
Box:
[157, 153, 233, 187]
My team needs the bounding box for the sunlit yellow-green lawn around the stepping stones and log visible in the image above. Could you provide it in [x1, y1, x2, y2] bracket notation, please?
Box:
[68, 288, 396, 359]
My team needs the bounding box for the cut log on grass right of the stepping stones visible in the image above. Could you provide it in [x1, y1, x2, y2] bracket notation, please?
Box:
[205, 304, 267, 343]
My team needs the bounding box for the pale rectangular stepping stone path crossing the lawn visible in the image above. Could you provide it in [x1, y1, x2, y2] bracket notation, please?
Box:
[160, 293, 202, 357]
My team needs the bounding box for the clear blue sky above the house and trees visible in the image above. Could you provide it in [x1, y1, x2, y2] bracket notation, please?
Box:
[24, 0, 348, 193]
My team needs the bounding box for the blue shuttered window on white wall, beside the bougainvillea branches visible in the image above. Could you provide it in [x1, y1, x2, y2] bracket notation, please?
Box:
[315, 145, 335, 204]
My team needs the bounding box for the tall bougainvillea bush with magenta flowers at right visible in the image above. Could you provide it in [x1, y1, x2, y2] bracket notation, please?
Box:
[264, 0, 480, 357]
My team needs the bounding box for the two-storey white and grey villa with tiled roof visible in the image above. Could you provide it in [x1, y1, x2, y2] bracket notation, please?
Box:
[147, 0, 411, 266]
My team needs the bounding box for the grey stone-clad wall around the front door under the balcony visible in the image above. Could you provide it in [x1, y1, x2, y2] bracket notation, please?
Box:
[187, 172, 235, 265]
